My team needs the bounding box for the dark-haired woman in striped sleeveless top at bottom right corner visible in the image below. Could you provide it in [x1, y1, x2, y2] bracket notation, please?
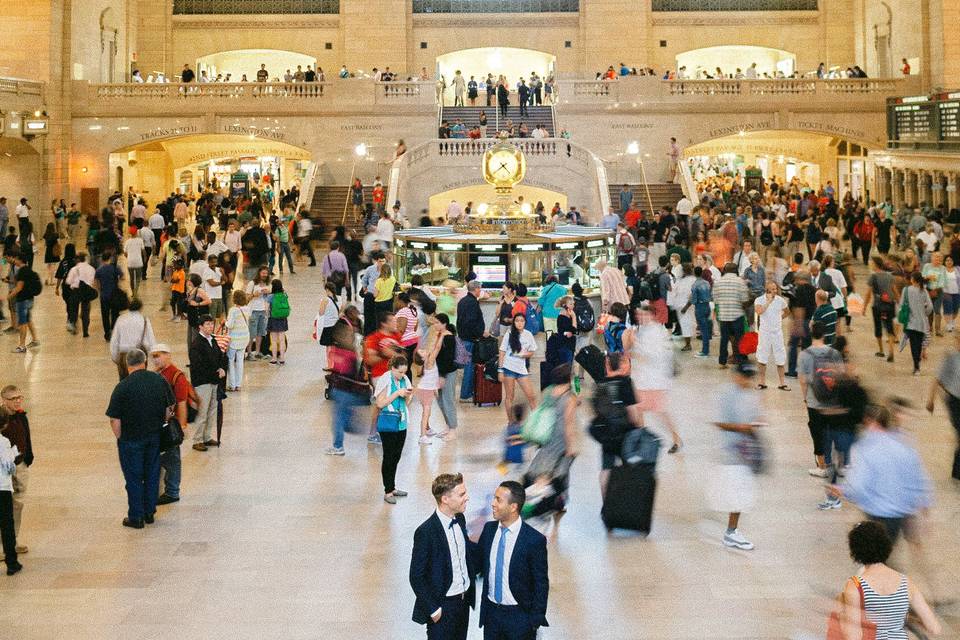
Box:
[841, 520, 941, 640]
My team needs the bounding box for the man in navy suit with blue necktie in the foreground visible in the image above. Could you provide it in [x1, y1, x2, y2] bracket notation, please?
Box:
[478, 480, 550, 640]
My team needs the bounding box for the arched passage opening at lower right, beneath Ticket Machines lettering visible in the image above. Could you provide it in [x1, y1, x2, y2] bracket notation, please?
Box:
[683, 130, 873, 199]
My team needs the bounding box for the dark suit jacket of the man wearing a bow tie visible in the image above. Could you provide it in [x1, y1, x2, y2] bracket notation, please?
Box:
[410, 513, 478, 624]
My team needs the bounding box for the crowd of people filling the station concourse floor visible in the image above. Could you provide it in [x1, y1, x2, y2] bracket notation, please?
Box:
[0, 175, 960, 637]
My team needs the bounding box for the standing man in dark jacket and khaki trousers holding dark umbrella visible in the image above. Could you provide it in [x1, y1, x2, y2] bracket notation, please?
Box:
[189, 314, 227, 451]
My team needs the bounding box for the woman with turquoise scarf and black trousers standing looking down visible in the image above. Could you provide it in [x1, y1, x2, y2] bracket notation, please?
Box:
[373, 356, 413, 504]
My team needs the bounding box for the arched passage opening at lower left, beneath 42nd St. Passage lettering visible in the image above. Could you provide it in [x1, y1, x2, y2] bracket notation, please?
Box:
[107, 134, 311, 204]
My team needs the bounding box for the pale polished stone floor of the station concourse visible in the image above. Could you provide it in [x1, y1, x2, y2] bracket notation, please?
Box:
[0, 267, 960, 640]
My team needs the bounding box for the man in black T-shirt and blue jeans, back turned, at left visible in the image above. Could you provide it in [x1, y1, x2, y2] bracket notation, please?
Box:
[107, 349, 175, 529]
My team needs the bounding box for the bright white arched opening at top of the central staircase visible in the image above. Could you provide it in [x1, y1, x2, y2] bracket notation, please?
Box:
[437, 47, 557, 92]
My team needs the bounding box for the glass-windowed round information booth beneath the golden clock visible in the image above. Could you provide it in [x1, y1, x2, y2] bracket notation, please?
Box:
[394, 227, 616, 297]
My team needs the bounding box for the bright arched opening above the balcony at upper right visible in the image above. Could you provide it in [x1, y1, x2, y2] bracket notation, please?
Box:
[677, 44, 797, 78]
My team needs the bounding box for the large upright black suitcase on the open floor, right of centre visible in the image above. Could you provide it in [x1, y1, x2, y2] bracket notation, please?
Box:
[600, 464, 657, 535]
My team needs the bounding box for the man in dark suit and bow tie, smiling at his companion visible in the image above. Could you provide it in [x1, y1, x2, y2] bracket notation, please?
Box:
[410, 473, 477, 640]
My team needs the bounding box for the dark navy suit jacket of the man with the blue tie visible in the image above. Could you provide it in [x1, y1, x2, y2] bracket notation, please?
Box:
[477, 521, 550, 629]
